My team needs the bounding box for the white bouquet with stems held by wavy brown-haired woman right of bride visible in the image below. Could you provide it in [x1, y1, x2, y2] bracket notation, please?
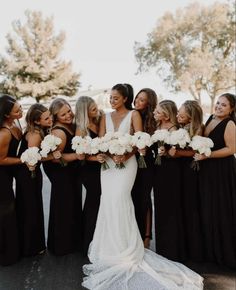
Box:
[132, 131, 152, 168]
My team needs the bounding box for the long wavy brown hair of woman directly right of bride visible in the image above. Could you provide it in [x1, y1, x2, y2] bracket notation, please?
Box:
[134, 88, 158, 134]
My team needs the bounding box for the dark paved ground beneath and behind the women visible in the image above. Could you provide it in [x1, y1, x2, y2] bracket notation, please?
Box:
[0, 169, 236, 290]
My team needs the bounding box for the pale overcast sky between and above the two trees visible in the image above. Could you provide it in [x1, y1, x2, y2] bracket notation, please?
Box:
[0, 0, 221, 104]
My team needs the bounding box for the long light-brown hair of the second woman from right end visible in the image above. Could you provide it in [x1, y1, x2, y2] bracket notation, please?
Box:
[183, 100, 203, 137]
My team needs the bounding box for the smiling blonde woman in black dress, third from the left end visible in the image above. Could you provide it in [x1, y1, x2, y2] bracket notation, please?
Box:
[44, 98, 82, 255]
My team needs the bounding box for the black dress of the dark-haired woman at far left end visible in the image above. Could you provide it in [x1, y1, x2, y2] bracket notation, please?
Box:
[0, 129, 19, 266]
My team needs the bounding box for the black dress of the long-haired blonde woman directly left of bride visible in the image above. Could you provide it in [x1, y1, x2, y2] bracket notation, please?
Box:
[79, 130, 101, 255]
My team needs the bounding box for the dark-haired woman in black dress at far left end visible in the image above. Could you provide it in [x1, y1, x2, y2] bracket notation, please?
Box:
[0, 95, 22, 266]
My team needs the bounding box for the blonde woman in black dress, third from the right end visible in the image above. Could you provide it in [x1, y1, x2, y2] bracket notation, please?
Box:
[151, 100, 185, 261]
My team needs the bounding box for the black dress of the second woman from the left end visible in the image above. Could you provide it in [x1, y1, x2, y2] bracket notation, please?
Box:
[16, 133, 46, 257]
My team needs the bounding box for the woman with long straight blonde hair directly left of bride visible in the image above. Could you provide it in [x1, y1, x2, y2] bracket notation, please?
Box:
[75, 96, 101, 255]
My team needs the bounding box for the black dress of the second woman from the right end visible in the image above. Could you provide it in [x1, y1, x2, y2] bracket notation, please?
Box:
[179, 157, 203, 262]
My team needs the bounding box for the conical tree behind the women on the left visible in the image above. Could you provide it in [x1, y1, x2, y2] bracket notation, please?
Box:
[0, 10, 79, 102]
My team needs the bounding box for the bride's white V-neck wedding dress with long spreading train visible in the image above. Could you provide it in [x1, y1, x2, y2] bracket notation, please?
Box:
[82, 111, 203, 290]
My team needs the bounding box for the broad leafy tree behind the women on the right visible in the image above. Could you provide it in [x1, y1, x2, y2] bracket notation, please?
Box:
[134, 3, 236, 111]
